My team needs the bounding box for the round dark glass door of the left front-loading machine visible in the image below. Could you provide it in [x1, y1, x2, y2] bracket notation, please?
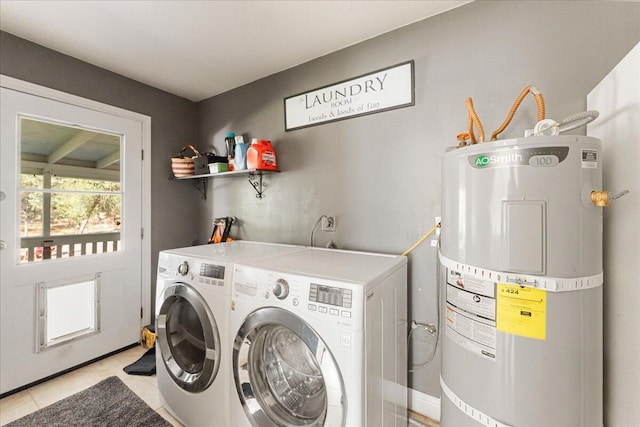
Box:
[156, 283, 221, 393]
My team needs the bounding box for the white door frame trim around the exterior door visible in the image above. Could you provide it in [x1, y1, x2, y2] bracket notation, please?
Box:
[0, 74, 152, 323]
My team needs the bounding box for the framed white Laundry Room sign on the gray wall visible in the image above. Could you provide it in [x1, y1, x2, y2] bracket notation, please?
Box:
[284, 60, 415, 131]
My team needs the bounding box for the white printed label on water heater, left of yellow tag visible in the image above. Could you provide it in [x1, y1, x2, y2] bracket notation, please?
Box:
[445, 270, 496, 361]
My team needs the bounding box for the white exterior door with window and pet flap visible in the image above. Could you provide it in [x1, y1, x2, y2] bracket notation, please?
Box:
[0, 88, 142, 393]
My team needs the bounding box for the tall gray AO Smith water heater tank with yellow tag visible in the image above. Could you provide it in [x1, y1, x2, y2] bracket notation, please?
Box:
[440, 135, 606, 427]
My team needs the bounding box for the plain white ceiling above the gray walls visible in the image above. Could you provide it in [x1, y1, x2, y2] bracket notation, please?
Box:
[0, 0, 468, 101]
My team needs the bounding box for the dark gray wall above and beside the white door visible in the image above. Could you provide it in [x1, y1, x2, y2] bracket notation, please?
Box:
[0, 32, 202, 320]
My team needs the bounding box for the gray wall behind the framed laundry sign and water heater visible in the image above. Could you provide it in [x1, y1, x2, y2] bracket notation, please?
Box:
[199, 1, 640, 408]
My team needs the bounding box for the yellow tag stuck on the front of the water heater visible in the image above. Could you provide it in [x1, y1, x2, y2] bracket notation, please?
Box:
[496, 283, 547, 340]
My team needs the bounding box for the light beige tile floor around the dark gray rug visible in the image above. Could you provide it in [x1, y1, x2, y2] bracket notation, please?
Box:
[0, 346, 182, 426]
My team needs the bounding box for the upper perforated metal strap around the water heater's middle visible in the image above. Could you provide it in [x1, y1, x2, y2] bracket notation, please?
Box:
[439, 253, 603, 292]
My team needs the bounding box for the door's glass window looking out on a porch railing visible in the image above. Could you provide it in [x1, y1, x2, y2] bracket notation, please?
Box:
[18, 117, 122, 263]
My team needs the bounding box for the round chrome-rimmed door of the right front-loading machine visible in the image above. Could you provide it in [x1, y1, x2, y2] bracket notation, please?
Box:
[233, 307, 347, 426]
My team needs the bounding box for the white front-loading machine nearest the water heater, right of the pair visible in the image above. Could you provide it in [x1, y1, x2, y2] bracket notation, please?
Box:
[230, 248, 407, 427]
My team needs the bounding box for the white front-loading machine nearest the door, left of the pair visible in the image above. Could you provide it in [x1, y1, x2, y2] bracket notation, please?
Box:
[156, 241, 301, 427]
